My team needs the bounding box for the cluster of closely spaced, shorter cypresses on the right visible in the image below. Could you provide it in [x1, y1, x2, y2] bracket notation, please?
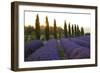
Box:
[64, 21, 84, 38]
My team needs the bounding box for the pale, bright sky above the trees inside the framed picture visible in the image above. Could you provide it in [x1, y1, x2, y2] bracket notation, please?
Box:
[25, 11, 91, 32]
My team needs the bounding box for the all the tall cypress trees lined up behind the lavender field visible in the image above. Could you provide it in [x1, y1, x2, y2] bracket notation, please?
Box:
[35, 14, 84, 40]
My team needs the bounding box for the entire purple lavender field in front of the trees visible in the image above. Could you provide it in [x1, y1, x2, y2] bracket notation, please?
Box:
[24, 35, 90, 61]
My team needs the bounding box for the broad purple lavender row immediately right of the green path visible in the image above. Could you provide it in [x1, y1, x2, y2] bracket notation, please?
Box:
[61, 39, 90, 59]
